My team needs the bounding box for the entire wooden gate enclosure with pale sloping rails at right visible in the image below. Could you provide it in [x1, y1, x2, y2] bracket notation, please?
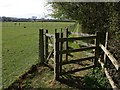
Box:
[39, 29, 120, 89]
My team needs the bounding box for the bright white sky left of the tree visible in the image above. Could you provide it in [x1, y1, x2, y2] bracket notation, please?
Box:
[0, 0, 51, 18]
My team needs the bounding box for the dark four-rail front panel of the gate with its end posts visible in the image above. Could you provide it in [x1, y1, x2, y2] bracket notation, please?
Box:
[54, 29, 100, 80]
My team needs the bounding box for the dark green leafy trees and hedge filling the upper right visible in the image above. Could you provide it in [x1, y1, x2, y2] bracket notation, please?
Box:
[50, 2, 120, 59]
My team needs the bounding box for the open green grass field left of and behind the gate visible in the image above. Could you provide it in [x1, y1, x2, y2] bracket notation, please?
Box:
[2, 22, 74, 88]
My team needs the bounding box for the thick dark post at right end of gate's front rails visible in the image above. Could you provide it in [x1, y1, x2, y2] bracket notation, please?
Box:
[94, 32, 100, 67]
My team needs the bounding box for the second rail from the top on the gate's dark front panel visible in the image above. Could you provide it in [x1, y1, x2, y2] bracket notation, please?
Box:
[58, 46, 96, 54]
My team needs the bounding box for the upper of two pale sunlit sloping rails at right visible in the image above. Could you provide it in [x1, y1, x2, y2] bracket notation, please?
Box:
[100, 44, 120, 70]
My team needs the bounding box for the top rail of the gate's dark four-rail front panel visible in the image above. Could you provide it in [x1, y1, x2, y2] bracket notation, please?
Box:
[58, 36, 96, 42]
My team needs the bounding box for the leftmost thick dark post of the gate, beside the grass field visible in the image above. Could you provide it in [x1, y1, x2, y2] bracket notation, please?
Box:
[39, 29, 44, 64]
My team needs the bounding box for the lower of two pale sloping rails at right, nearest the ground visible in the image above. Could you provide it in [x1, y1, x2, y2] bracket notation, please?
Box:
[98, 59, 118, 90]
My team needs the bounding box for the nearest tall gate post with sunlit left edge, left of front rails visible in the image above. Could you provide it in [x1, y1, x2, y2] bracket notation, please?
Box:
[54, 33, 59, 80]
